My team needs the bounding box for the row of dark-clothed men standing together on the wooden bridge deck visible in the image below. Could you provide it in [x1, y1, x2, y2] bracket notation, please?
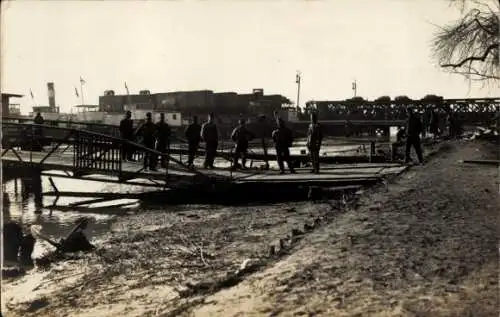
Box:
[120, 111, 323, 174]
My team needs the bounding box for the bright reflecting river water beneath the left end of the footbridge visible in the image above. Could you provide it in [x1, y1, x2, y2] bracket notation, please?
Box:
[2, 175, 146, 257]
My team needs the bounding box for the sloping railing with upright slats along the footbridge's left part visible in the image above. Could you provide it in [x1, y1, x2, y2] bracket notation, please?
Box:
[2, 122, 205, 183]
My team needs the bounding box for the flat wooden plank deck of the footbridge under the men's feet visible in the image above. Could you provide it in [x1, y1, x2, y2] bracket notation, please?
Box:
[2, 151, 406, 186]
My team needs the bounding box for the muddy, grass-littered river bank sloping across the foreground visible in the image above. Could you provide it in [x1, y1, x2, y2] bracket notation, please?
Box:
[2, 141, 500, 316]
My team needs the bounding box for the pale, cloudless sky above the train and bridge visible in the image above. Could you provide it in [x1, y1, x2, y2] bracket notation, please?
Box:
[1, 0, 498, 113]
